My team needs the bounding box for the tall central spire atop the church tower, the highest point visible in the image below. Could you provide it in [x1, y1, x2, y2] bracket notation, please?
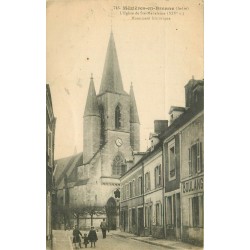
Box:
[99, 31, 126, 94]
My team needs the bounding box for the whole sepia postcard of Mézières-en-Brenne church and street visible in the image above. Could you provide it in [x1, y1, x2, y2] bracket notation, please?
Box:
[44, 0, 206, 250]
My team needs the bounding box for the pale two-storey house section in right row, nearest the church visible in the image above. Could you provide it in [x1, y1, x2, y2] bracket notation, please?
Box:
[120, 120, 168, 238]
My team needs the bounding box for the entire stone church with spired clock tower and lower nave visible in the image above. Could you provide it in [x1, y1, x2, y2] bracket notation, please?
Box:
[53, 31, 142, 229]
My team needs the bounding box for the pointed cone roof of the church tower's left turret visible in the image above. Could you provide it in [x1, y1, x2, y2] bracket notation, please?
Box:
[84, 74, 100, 116]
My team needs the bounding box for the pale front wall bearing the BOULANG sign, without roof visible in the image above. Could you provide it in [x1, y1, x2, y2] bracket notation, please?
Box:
[181, 112, 204, 244]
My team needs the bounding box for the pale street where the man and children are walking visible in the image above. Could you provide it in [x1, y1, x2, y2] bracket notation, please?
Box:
[53, 230, 170, 250]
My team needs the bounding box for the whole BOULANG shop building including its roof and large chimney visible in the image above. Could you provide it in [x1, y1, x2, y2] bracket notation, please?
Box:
[180, 79, 204, 245]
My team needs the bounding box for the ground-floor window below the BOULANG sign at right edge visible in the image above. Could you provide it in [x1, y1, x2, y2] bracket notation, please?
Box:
[191, 195, 203, 227]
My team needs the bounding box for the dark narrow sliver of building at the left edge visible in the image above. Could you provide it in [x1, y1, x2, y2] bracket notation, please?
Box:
[46, 84, 56, 248]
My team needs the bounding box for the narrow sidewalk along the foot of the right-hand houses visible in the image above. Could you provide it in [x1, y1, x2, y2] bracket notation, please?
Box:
[109, 230, 203, 250]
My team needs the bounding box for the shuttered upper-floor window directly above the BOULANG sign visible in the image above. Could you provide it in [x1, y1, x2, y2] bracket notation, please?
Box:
[188, 142, 202, 175]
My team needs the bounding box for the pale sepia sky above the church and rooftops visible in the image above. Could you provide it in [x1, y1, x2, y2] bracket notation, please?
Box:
[46, 0, 204, 159]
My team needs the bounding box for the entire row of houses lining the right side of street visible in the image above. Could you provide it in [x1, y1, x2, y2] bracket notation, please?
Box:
[120, 79, 204, 245]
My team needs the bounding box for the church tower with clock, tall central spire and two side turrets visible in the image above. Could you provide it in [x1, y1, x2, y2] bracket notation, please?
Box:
[83, 31, 140, 178]
